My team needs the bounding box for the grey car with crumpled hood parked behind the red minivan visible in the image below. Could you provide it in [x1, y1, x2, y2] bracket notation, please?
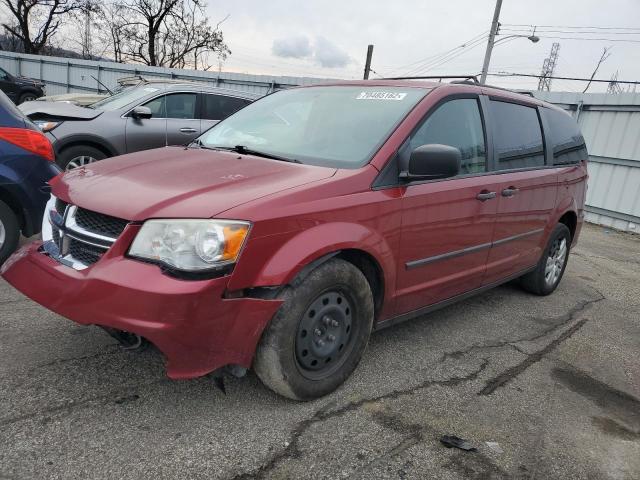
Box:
[21, 82, 259, 170]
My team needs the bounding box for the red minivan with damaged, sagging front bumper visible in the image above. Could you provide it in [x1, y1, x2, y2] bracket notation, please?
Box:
[2, 80, 587, 400]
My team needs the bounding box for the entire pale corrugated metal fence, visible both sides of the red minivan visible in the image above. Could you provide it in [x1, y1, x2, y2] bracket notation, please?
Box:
[0, 52, 640, 231]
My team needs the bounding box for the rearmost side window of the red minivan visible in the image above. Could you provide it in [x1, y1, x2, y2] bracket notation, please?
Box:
[544, 108, 588, 165]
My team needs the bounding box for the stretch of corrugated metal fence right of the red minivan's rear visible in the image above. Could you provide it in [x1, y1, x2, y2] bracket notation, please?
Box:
[534, 92, 640, 232]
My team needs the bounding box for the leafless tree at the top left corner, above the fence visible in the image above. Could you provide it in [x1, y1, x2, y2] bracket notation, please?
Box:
[0, 0, 86, 54]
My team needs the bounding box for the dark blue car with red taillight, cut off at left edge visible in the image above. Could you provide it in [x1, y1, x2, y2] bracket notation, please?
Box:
[0, 92, 60, 265]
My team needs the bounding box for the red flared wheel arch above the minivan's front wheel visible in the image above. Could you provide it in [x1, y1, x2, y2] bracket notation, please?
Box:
[228, 222, 396, 296]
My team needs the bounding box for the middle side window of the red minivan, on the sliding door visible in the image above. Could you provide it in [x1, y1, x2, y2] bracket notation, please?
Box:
[490, 101, 544, 170]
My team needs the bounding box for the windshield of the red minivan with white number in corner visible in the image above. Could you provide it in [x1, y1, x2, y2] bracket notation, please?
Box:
[197, 86, 428, 168]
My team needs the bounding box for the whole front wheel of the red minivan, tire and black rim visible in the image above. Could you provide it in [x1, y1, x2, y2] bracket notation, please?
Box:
[254, 258, 374, 400]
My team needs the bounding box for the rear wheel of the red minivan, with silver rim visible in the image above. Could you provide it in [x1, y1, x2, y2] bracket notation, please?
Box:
[520, 223, 571, 296]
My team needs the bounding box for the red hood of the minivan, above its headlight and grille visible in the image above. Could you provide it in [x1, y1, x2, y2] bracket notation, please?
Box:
[51, 147, 336, 221]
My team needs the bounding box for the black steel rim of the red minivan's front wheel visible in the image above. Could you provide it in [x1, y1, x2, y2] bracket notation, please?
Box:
[295, 289, 356, 380]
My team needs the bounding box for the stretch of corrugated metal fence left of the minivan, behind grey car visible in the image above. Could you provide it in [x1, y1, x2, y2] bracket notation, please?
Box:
[0, 51, 329, 95]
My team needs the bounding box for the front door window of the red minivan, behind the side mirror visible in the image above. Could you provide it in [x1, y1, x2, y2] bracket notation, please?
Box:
[402, 98, 487, 174]
